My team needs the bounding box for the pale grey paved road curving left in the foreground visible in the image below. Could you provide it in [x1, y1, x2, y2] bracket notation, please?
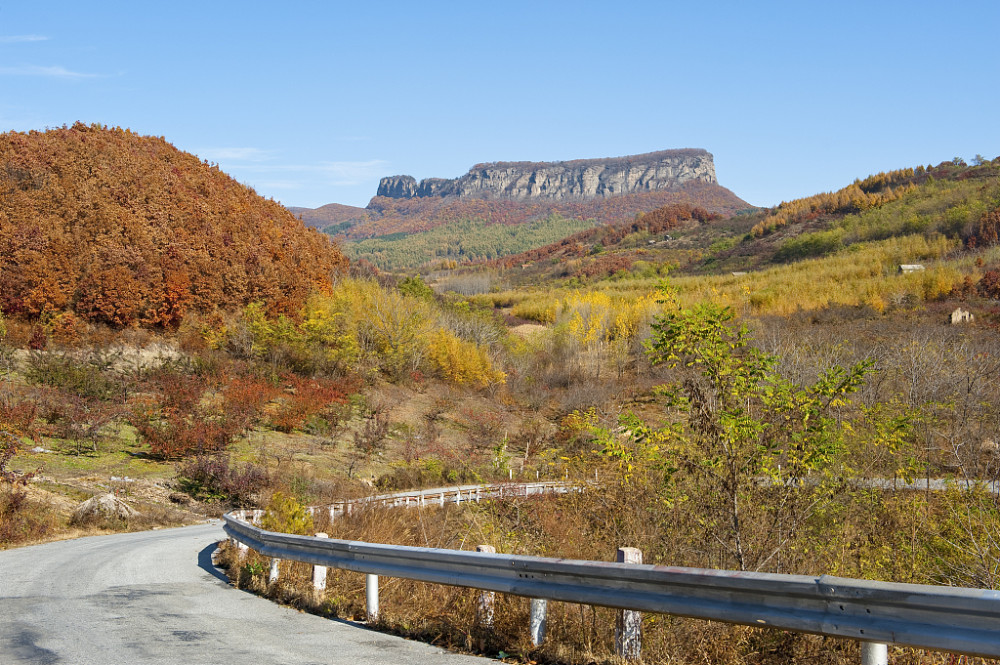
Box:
[0, 523, 488, 665]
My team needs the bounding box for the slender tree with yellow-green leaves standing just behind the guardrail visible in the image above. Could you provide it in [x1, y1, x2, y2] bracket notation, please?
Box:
[648, 288, 871, 570]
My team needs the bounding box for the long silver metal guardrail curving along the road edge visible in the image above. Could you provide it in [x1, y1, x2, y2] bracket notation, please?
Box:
[224, 483, 1000, 662]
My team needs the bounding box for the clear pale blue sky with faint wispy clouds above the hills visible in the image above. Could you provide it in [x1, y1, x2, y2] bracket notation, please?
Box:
[0, 0, 1000, 207]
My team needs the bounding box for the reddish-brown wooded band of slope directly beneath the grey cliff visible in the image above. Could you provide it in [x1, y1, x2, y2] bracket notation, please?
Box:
[342, 181, 753, 240]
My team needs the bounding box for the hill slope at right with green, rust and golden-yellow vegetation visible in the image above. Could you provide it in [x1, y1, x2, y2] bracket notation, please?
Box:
[468, 158, 1000, 325]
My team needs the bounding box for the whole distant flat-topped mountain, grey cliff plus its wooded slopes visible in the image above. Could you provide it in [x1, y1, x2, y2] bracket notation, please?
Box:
[290, 149, 754, 270]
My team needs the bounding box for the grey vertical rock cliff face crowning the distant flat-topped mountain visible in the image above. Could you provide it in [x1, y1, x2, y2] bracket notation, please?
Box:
[378, 150, 718, 201]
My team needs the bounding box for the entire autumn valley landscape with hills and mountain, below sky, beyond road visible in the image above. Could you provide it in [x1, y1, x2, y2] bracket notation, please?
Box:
[0, 123, 1000, 664]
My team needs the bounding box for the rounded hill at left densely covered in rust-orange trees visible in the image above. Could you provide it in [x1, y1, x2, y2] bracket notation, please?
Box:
[0, 123, 347, 326]
